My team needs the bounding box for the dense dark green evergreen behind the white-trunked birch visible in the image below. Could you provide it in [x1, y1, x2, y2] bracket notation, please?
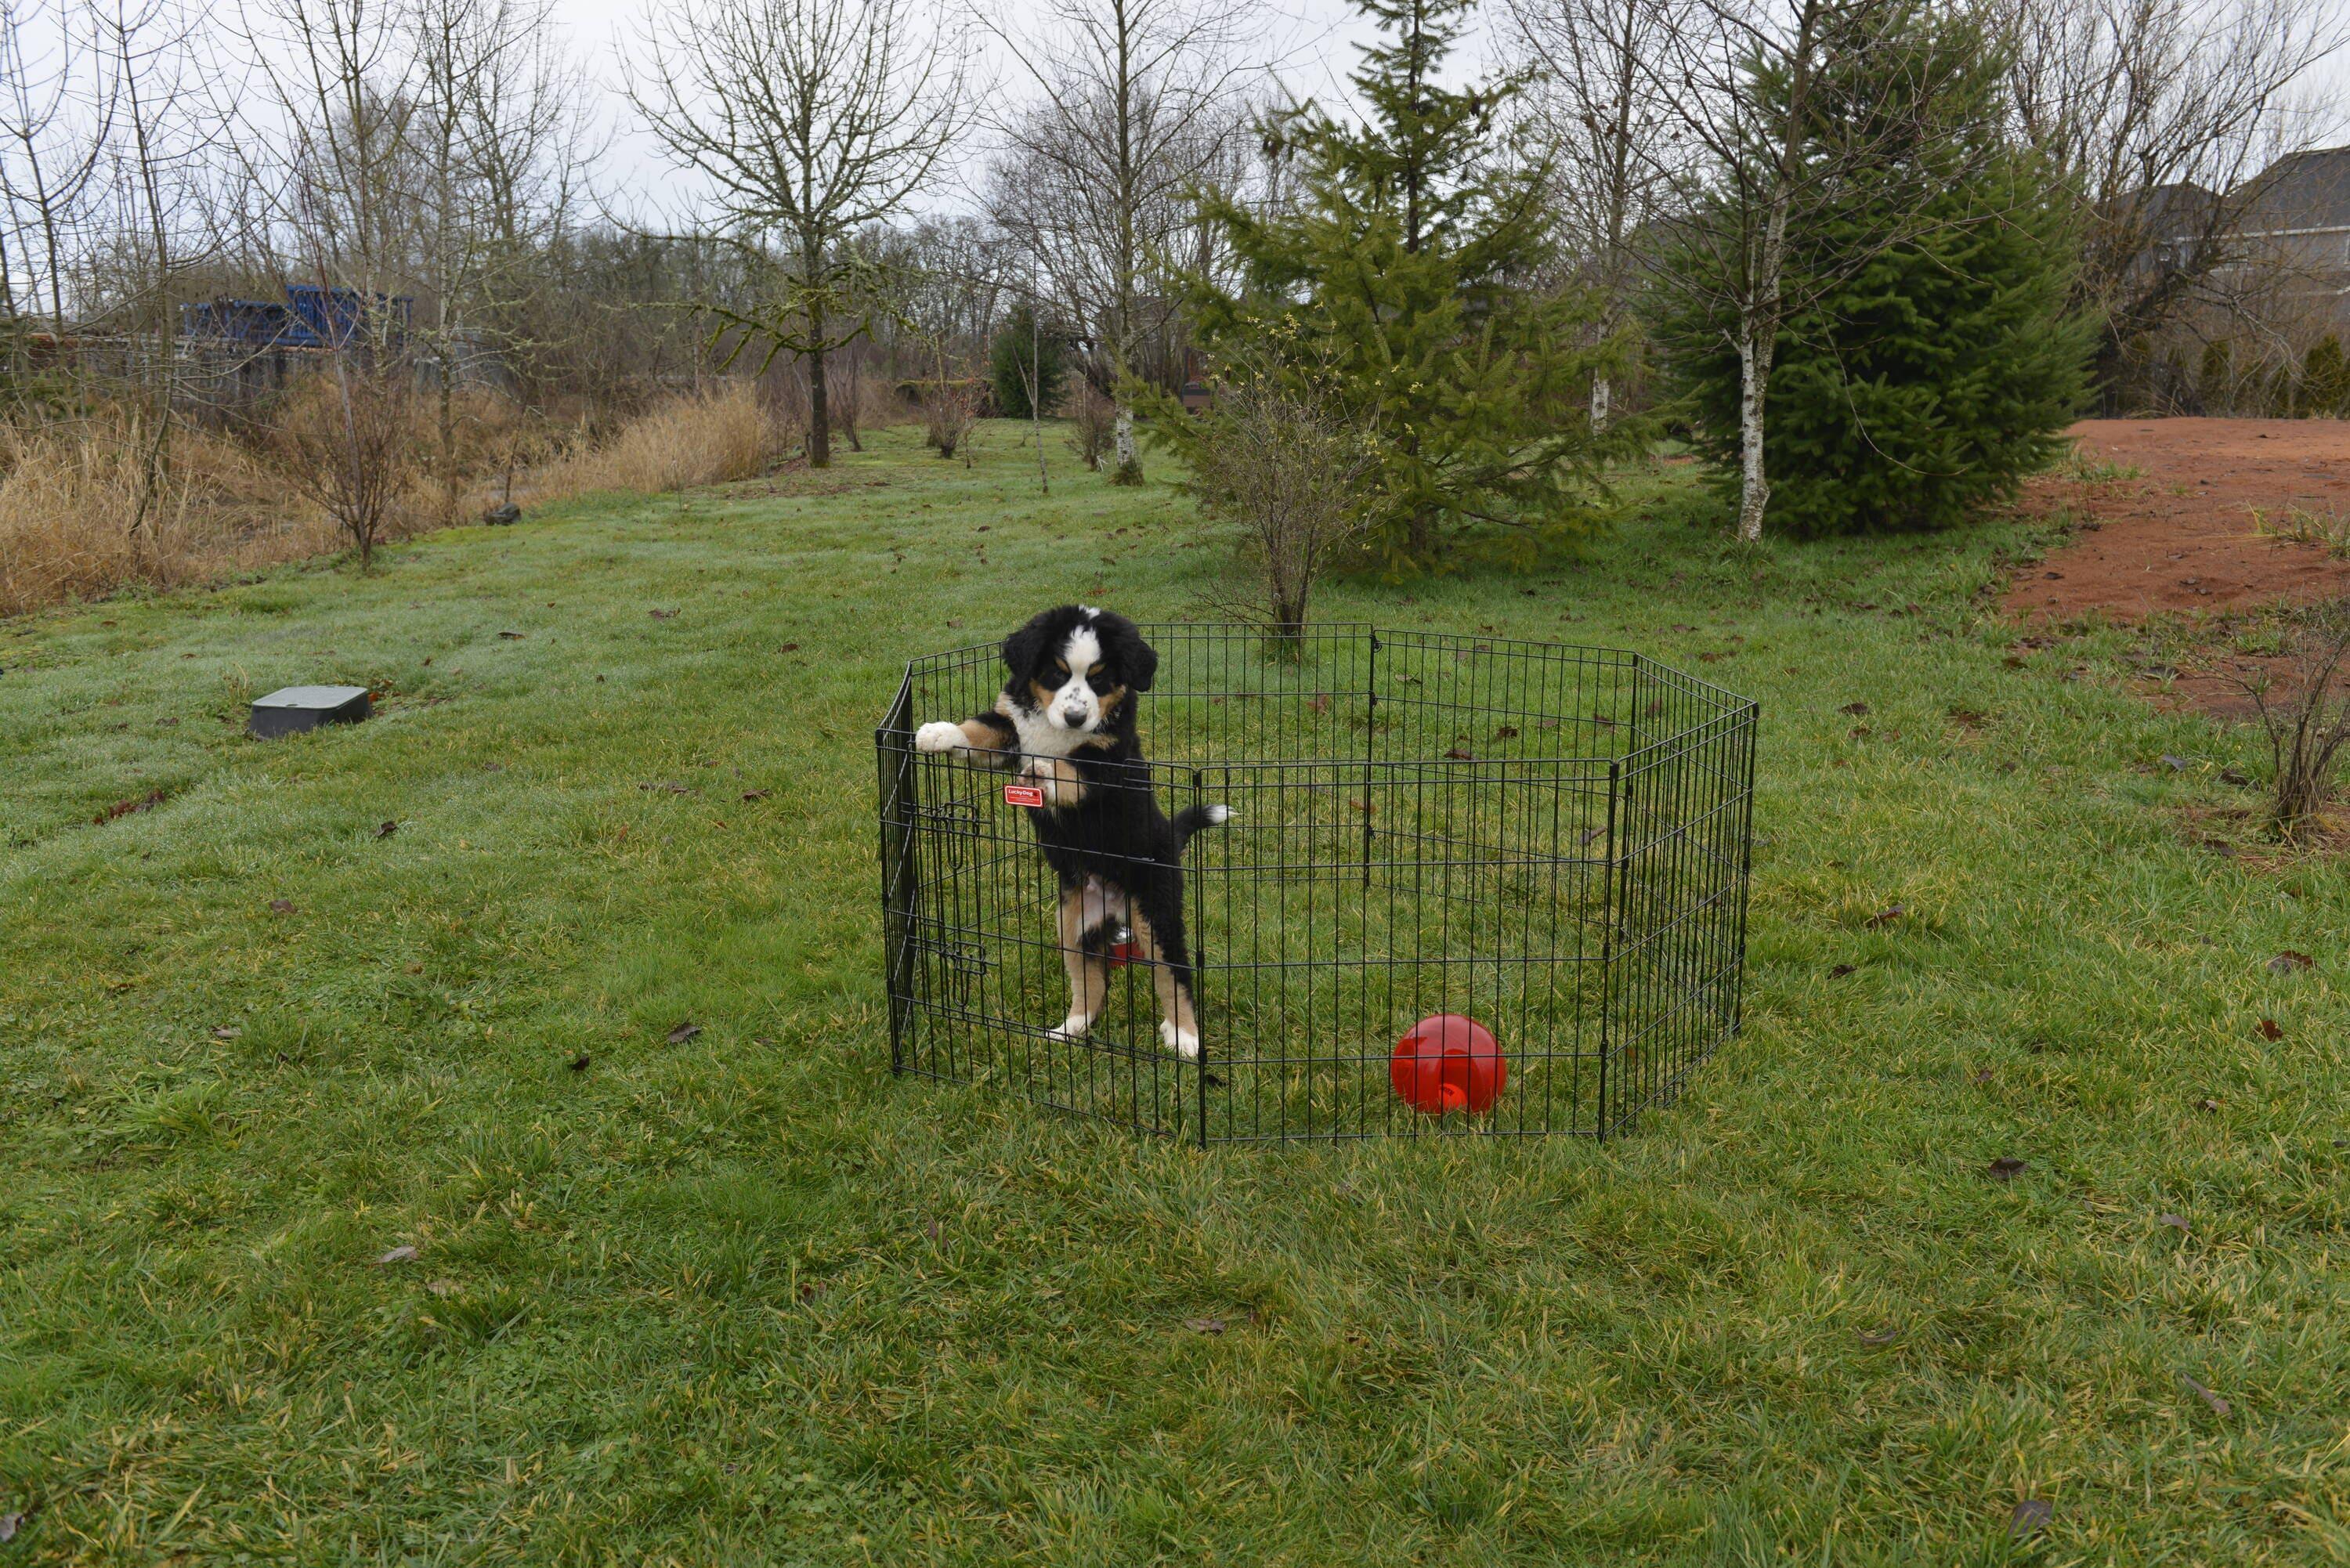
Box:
[1659, 9, 2092, 533]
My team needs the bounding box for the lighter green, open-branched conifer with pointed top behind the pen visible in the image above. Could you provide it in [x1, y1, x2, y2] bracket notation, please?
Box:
[1144, 0, 1640, 571]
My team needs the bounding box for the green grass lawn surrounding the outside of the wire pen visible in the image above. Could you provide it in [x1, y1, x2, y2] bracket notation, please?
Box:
[0, 425, 2350, 1563]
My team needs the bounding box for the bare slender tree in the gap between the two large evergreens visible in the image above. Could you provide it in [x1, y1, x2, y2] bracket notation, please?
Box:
[1509, 0, 1685, 428]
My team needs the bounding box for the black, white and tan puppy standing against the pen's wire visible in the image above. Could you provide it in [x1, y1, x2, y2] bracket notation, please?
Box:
[914, 604, 1231, 1058]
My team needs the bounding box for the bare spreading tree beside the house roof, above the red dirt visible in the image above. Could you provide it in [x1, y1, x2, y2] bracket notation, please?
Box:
[1998, 0, 2350, 399]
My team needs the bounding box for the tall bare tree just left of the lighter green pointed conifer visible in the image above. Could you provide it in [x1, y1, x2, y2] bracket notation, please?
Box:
[989, 0, 1246, 484]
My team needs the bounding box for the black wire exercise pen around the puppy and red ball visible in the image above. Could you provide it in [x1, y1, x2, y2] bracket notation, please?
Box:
[877, 625, 1755, 1145]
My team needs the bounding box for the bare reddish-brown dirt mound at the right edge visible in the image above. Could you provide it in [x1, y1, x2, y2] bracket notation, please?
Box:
[2007, 418, 2350, 620]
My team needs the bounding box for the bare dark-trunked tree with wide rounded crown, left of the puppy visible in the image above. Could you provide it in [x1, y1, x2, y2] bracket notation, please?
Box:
[627, 0, 964, 468]
